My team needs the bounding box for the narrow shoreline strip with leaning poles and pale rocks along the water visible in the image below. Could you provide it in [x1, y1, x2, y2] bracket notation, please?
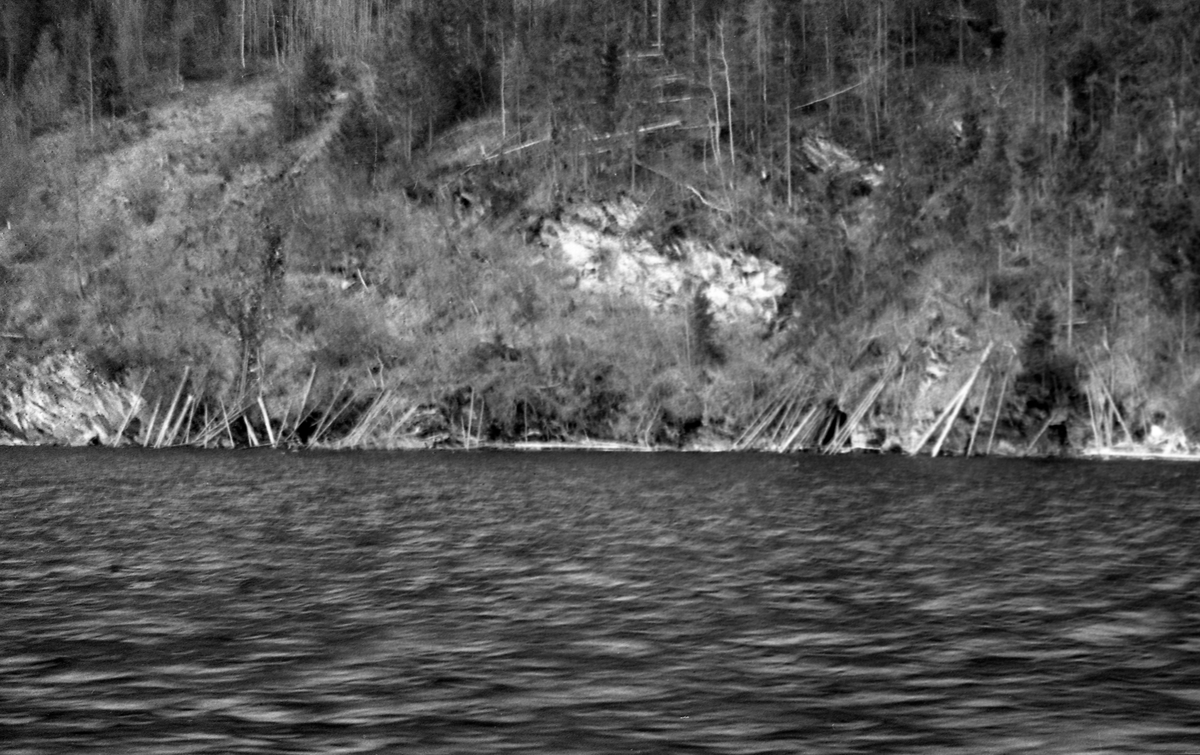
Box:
[0, 350, 1200, 461]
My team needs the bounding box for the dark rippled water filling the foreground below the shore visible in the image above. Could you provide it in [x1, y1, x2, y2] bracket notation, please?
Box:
[0, 449, 1200, 755]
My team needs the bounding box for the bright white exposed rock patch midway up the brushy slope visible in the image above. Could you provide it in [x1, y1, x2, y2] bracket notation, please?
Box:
[541, 199, 787, 323]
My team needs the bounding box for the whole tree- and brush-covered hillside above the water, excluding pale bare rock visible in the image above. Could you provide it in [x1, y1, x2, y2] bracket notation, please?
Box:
[0, 0, 1200, 453]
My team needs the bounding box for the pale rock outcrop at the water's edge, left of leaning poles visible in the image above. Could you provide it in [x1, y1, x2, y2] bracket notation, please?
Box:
[0, 353, 134, 445]
